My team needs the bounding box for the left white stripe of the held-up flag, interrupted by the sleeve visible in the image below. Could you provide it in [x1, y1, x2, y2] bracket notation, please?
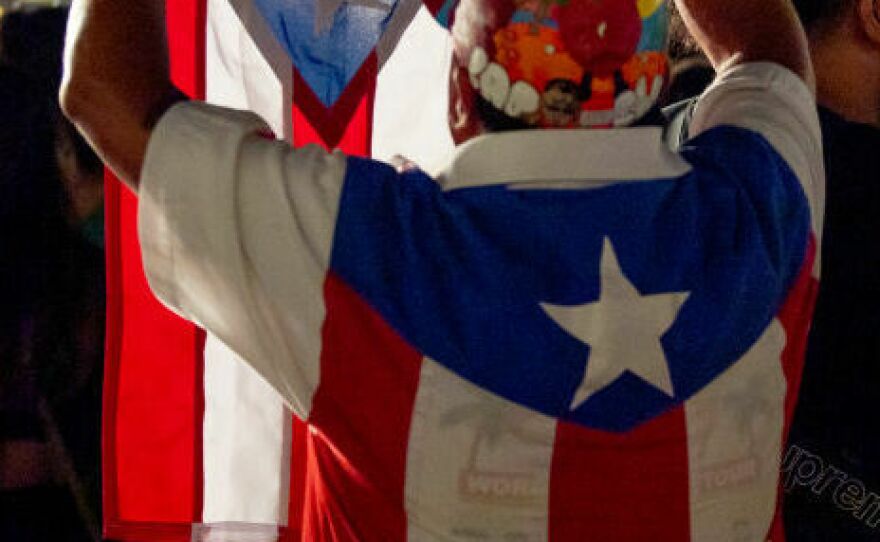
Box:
[202, 0, 293, 528]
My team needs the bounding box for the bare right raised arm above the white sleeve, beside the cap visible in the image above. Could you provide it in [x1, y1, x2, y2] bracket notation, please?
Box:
[675, 0, 815, 92]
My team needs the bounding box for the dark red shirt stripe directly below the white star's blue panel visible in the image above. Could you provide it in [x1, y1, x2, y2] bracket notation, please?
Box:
[548, 407, 690, 542]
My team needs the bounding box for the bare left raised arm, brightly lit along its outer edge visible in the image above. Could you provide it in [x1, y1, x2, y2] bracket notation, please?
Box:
[60, 0, 174, 190]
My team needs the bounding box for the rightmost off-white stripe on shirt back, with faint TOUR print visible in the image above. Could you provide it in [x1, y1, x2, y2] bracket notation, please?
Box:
[685, 320, 786, 542]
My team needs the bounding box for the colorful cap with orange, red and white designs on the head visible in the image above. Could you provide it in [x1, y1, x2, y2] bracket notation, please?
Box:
[458, 0, 668, 128]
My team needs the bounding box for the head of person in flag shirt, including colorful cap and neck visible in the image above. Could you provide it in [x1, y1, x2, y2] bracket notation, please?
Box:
[436, 0, 669, 142]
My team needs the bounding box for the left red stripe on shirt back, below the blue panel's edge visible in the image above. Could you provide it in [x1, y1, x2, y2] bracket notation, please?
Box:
[303, 274, 422, 542]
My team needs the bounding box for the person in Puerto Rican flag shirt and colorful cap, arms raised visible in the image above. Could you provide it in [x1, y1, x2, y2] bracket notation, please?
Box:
[62, 0, 824, 541]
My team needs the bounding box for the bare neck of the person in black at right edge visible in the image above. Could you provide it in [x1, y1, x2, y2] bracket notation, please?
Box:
[810, 29, 880, 127]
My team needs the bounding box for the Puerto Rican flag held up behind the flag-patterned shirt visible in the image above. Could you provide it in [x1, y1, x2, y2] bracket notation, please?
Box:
[103, 0, 452, 542]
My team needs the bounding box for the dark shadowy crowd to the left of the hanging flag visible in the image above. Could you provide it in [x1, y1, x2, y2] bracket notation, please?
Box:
[0, 8, 104, 542]
